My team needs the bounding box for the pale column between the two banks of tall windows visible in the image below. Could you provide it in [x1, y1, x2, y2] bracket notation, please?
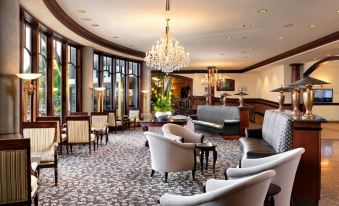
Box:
[82, 47, 94, 113]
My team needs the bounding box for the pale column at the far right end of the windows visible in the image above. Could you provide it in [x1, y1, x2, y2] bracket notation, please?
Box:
[140, 63, 151, 116]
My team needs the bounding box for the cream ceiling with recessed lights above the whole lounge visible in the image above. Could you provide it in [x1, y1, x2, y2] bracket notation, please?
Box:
[21, 0, 339, 69]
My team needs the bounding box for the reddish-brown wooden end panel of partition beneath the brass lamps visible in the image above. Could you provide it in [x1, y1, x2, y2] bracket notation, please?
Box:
[292, 117, 325, 203]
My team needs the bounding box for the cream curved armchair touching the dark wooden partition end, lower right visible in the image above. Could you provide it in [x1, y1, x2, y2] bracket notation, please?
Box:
[226, 148, 305, 206]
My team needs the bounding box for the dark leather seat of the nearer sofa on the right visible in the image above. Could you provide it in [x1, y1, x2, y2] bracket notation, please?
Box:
[239, 137, 276, 159]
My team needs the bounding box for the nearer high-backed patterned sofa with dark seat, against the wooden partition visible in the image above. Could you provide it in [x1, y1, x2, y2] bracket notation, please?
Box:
[239, 110, 293, 159]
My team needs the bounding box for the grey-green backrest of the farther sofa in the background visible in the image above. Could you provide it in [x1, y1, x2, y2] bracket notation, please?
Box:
[197, 105, 240, 124]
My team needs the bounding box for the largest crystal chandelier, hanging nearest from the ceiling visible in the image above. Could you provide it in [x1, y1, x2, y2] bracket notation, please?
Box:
[145, 19, 190, 74]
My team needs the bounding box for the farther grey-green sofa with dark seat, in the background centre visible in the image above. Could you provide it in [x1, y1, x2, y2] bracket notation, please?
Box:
[192, 105, 240, 135]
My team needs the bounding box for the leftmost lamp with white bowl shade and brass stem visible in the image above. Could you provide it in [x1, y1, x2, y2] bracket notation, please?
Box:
[16, 73, 41, 122]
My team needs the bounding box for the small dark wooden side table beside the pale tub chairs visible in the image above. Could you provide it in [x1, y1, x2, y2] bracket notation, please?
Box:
[195, 142, 218, 174]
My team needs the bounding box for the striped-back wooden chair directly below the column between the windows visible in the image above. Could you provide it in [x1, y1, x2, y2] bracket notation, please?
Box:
[66, 116, 95, 154]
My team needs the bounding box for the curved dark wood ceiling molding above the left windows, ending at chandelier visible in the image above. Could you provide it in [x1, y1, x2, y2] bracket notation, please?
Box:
[43, 0, 145, 58]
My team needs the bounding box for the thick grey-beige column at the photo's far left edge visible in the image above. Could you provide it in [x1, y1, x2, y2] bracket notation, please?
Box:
[0, 0, 20, 138]
